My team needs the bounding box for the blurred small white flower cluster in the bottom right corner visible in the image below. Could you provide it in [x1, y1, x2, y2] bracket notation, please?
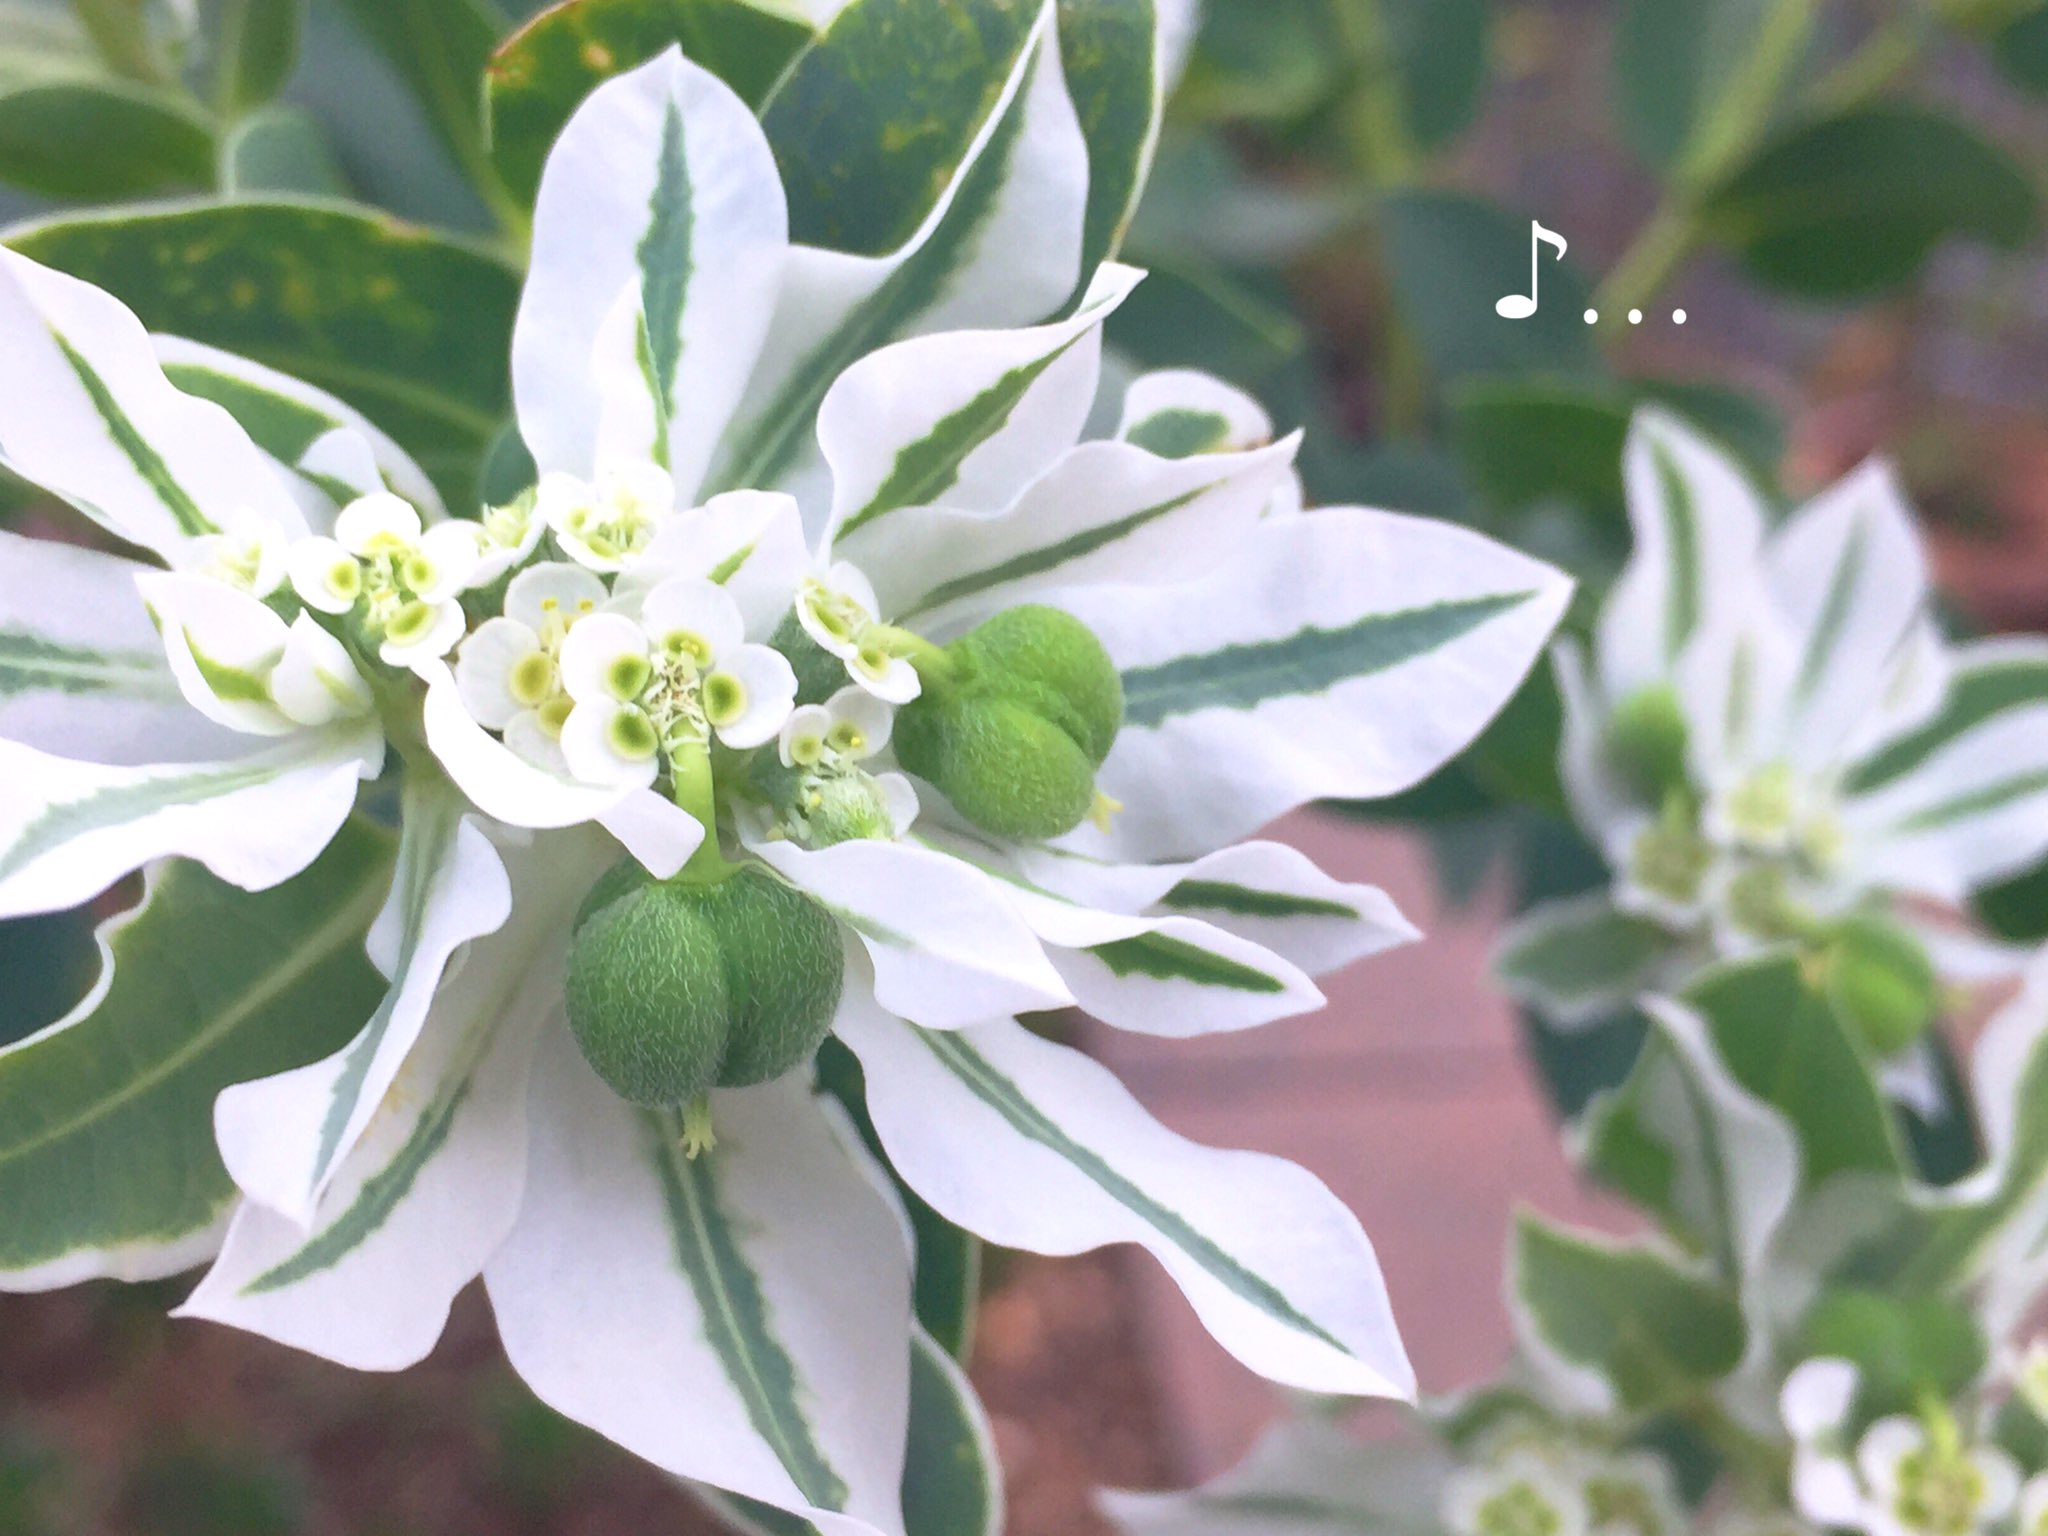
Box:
[1780, 1358, 2048, 1536]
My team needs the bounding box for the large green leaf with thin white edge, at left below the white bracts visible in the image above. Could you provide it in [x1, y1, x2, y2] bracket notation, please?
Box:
[0, 823, 391, 1290]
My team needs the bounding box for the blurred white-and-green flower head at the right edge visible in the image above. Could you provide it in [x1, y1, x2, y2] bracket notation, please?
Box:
[1499, 410, 2048, 1028]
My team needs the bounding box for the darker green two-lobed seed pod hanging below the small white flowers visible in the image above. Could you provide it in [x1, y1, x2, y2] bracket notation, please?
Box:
[563, 860, 846, 1108]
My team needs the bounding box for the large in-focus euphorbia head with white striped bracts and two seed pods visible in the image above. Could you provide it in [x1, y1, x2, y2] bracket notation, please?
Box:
[0, 6, 1569, 1532]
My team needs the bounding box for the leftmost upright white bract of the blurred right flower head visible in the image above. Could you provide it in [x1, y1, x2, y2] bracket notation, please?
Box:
[1595, 408, 1763, 698]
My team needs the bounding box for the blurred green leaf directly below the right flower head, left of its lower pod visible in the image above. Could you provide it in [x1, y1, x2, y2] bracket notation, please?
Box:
[1683, 950, 1903, 1192]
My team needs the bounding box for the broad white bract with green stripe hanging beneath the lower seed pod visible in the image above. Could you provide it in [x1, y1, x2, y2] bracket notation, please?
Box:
[483, 1030, 911, 1536]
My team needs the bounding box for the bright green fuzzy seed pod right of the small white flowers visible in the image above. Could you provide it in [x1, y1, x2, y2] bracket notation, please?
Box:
[893, 606, 1124, 842]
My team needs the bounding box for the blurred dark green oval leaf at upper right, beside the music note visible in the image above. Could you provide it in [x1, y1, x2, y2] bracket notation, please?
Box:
[1700, 104, 2040, 299]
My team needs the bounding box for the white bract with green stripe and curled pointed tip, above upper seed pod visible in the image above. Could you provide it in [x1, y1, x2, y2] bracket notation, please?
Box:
[817, 266, 1141, 539]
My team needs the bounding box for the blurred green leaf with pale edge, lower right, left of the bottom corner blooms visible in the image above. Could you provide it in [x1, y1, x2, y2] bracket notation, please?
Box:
[1513, 1214, 1749, 1413]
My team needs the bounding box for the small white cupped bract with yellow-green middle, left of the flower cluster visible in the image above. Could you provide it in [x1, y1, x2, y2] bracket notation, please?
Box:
[135, 573, 299, 735]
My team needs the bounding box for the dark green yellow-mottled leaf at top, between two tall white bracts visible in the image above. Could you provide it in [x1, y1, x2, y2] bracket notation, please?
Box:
[762, 0, 1042, 256]
